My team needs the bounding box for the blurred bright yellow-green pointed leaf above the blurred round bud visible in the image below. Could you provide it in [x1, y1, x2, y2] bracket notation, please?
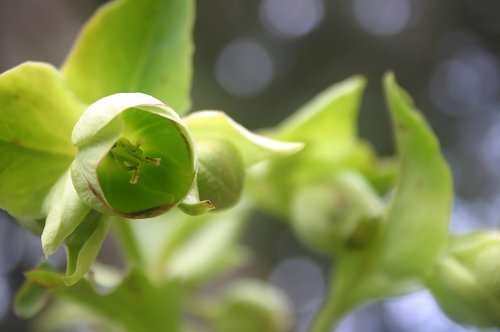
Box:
[248, 77, 374, 219]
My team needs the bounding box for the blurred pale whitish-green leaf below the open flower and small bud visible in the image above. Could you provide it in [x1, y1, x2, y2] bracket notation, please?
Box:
[128, 201, 250, 282]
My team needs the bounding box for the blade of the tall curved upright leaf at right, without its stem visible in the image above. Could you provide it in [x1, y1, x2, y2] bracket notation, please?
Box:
[381, 74, 453, 276]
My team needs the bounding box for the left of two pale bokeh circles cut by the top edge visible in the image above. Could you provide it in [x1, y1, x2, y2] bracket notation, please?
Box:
[259, 0, 325, 38]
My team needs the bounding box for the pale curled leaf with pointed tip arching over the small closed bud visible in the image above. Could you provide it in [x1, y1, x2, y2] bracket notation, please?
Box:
[184, 111, 303, 167]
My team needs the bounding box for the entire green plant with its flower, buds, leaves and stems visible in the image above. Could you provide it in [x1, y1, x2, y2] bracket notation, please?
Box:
[0, 0, 500, 332]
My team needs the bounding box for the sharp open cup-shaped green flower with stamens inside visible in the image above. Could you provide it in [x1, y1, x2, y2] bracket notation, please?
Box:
[71, 93, 196, 218]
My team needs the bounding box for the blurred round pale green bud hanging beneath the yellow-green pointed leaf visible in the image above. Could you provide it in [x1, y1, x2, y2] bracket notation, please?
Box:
[292, 172, 382, 255]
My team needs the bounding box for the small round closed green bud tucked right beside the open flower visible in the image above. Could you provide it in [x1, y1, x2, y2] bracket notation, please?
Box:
[196, 140, 245, 210]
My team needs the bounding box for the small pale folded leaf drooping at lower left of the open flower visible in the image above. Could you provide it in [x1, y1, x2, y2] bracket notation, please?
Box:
[41, 171, 90, 257]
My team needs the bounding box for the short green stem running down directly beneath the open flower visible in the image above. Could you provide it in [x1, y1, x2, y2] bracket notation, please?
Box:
[112, 218, 145, 268]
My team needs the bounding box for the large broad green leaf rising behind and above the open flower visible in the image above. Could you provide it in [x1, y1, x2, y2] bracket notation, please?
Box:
[62, 0, 194, 113]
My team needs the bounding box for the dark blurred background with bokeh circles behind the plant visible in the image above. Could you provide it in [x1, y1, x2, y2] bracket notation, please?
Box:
[0, 0, 500, 332]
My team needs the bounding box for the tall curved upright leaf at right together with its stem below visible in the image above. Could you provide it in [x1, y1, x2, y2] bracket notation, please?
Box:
[311, 74, 452, 332]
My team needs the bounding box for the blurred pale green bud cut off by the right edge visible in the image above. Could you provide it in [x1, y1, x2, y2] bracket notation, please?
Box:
[427, 231, 500, 327]
